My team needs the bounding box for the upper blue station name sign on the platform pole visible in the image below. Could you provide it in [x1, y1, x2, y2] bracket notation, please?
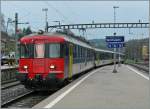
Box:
[106, 36, 124, 42]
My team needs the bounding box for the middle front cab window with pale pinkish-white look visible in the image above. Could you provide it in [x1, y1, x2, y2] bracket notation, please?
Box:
[35, 44, 45, 58]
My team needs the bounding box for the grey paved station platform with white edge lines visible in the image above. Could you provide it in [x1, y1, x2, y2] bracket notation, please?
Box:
[33, 65, 150, 109]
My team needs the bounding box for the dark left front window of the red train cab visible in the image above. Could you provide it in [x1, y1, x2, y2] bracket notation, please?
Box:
[20, 44, 34, 58]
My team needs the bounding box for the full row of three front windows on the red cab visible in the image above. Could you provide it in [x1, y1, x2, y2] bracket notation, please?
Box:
[20, 43, 63, 58]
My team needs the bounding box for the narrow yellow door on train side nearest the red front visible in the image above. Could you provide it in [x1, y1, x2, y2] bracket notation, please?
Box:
[68, 44, 73, 80]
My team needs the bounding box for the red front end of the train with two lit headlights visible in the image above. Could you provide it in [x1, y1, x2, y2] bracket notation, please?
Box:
[17, 35, 64, 90]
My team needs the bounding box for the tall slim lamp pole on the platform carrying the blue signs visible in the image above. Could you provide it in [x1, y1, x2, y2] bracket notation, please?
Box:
[113, 6, 119, 73]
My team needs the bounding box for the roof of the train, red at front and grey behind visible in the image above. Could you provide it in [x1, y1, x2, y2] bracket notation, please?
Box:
[20, 32, 123, 55]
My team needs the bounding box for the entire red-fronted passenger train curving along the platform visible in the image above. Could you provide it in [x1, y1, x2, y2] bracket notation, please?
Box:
[17, 32, 123, 90]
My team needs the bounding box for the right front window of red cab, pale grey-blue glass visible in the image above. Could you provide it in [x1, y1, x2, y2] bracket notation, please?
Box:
[48, 44, 61, 58]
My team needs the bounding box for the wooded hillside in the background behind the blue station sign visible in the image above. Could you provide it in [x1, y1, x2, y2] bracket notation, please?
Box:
[89, 38, 149, 61]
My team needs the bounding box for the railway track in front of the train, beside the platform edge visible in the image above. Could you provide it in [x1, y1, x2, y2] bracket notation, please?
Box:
[1, 87, 56, 108]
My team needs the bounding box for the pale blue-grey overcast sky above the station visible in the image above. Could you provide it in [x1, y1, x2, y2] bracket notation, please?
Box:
[2, 1, 149, 40]
